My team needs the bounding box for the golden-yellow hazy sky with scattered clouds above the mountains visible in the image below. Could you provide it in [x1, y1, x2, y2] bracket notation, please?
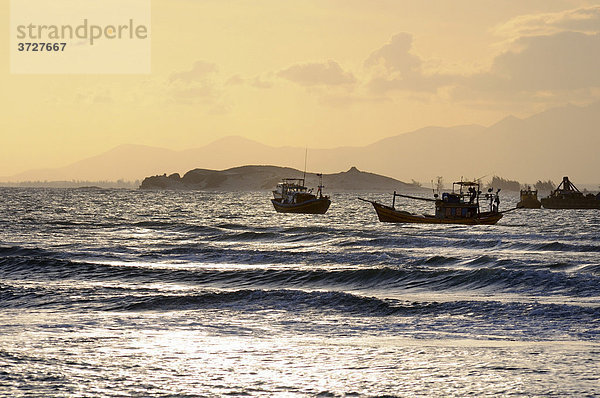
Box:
[0, 0, 600, 176]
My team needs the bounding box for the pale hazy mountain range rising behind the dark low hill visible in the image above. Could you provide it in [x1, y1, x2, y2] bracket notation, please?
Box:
[5, 102, 600, 183]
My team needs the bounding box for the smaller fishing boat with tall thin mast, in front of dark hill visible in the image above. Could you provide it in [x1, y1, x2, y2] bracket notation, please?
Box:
[271, 174, 331, 214]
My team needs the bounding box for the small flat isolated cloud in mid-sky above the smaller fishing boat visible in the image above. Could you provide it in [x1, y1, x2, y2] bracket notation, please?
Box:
[277, 61, 356, 86]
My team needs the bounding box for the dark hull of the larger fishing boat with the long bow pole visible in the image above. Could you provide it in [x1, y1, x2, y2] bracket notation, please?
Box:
[371, 202, 502, 225]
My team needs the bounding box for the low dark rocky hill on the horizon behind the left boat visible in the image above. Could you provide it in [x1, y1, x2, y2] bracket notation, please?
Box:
[140, 166, 423, 192]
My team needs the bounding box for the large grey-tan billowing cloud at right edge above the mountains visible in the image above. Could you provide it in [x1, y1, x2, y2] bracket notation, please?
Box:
[452, 32, 600, 103]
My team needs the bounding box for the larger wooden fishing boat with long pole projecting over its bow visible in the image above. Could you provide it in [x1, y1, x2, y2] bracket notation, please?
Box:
[359, 181, 503, 225]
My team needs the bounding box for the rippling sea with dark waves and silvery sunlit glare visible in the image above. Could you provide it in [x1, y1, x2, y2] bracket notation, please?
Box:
[0, 188, 600, 397]
